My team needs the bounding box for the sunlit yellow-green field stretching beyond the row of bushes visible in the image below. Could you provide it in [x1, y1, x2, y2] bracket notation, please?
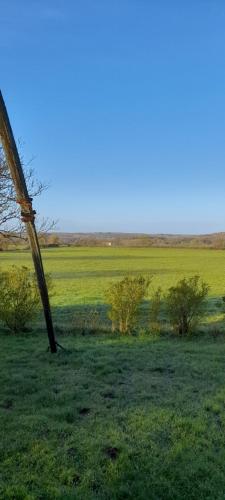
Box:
[0, 248, 225, 325]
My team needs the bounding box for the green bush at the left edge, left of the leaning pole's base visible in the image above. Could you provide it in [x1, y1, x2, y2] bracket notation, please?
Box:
[0, 266, 40, 333]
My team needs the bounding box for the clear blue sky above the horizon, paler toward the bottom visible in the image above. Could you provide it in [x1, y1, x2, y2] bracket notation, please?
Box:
[0, 0, 225, 233]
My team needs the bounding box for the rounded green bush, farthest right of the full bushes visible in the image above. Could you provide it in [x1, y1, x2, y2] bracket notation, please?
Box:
[166, 276, 209, 335]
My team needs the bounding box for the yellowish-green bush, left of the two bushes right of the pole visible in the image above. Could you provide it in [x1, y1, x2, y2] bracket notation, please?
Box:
[105, 275, 150, 334]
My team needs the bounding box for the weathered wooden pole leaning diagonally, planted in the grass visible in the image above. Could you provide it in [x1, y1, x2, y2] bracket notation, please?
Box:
[0, 91, 57, 353]
